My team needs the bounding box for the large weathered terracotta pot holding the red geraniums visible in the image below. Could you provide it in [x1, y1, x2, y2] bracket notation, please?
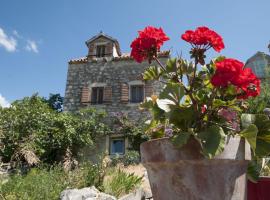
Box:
[141, 137, 251, 200]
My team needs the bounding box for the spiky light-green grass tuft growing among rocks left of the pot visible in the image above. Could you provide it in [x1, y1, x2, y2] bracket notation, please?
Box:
[104, 169, 142, 198]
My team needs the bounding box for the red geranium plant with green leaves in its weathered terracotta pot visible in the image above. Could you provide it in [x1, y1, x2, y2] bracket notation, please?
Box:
[128, 26, 270, 200]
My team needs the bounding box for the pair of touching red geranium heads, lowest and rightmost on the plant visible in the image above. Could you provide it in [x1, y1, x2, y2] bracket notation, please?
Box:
[211, 58, 260, 99]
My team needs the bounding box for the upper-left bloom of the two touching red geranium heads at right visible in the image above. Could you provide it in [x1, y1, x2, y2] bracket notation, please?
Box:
[211, 58, 244, 87]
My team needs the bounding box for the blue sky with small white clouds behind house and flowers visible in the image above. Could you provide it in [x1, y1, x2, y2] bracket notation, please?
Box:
[0, 0, 270, 105]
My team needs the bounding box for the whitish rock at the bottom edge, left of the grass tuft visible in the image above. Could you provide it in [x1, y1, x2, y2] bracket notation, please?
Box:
[60, 186, 116, 200]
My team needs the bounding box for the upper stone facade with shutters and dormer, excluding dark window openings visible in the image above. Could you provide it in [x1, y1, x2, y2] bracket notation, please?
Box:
[64, 32, 169, 120]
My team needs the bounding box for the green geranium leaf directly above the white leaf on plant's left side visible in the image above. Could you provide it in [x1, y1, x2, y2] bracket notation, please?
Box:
[159, 83, 185, 104]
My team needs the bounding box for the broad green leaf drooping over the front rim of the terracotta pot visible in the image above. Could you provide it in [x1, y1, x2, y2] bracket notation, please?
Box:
[197, 125, 226, 158]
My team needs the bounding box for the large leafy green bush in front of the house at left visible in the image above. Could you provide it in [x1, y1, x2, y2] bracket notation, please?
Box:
[0, 95, 109, 165]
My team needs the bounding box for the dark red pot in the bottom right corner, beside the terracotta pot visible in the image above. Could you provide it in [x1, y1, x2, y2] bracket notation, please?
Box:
[247, 177, 270, 200]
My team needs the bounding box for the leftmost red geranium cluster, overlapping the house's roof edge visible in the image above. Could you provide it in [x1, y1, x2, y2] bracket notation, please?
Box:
[130, 26, 169, 63]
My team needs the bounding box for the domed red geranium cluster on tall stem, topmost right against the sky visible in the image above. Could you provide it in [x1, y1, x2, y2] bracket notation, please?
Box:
[181, 26, 225, 52]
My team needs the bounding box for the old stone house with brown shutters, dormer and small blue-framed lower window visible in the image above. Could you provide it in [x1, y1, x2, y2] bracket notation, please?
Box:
[64, 32, 169, 157]
